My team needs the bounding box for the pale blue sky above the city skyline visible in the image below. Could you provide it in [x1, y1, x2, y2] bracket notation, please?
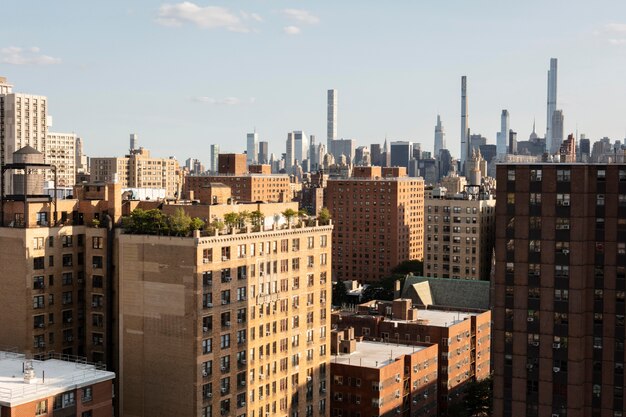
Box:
[0, 0, 626, 163]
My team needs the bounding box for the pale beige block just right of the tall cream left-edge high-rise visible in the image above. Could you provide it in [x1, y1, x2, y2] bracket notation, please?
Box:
[45, 131, 76, 187]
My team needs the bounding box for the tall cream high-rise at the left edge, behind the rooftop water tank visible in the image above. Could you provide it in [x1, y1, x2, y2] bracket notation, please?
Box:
[0, 77, 51, 192]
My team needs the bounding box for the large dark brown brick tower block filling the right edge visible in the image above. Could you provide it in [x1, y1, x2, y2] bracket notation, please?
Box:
[492, 164, 626, 417]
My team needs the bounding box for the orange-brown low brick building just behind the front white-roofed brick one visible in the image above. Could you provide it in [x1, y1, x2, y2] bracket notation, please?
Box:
[332, 299, 491, 415]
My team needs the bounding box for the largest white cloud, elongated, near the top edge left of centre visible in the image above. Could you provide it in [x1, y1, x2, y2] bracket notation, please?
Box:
[156, 1, 254, 33]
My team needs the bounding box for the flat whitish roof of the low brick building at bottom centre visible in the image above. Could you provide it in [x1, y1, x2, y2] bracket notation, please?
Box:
[331, 342, 425, 368]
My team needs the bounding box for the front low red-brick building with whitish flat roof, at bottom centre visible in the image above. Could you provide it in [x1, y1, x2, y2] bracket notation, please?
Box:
[330, 328, 437, 417]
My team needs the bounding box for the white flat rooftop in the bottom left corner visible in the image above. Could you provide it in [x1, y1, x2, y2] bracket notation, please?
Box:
[0, 351, 115, 407]
